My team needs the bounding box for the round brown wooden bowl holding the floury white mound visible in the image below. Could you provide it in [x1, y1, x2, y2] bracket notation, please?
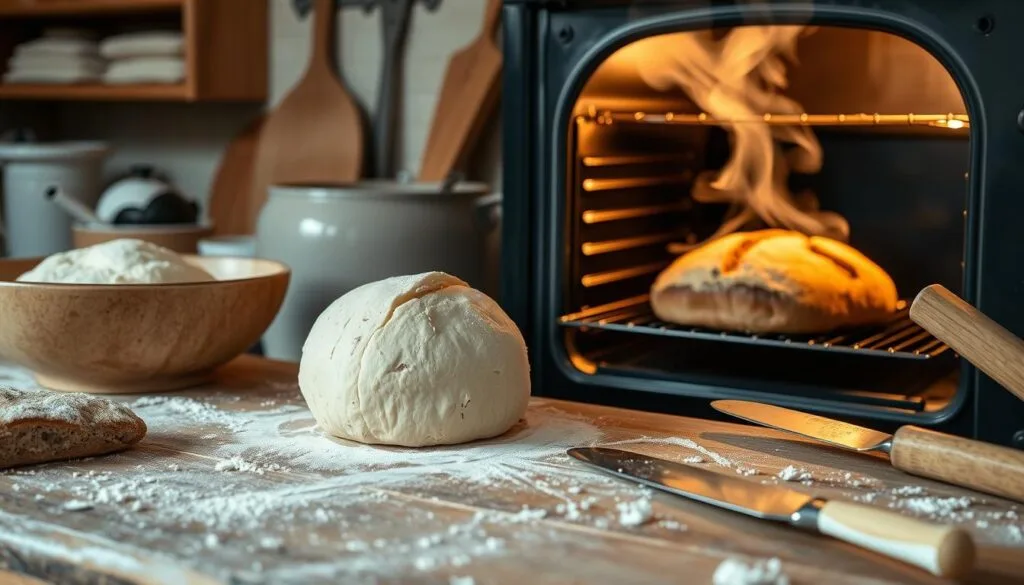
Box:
[0, 256, 291, 393]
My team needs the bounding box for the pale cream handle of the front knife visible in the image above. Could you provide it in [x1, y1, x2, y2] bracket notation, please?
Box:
[817, 501, 975, 577]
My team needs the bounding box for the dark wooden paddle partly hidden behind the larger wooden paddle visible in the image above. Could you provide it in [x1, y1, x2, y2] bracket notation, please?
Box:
[209, 115, 266, 236]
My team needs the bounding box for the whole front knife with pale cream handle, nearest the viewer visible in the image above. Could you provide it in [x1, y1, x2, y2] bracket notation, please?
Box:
[568, 447, 975, 577]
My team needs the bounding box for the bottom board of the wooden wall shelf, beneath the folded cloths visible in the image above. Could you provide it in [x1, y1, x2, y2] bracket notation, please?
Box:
[0, 83, 191, 101]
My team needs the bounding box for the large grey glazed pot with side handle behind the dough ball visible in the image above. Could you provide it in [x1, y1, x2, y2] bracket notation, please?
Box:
[256, 180, 501, 361]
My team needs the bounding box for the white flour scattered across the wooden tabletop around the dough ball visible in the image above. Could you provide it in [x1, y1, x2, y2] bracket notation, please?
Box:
[0, 364, 1024, 585]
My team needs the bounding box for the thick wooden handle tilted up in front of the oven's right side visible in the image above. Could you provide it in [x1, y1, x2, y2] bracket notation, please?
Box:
[910, 285, 1024, 401]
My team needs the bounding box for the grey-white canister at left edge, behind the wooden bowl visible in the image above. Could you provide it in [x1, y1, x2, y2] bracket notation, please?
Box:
[0, 141, 110, 258]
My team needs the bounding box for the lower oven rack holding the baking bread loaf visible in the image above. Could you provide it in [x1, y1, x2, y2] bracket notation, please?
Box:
[559, 294, 949, 361]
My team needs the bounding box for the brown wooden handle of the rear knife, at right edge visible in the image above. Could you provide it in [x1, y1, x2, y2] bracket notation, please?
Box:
[889, 425, 1024, 502]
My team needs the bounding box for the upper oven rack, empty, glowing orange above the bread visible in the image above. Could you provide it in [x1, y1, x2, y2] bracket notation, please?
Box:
[577, 107, 971, 130]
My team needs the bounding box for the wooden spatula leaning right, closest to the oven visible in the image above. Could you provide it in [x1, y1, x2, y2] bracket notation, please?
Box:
[420, 0, 502, 181]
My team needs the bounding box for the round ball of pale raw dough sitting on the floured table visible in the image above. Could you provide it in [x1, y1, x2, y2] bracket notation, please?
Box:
[299, 273, 530, 447]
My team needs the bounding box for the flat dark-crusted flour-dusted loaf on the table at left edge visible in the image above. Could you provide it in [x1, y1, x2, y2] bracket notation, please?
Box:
[0, 386, 146, 468]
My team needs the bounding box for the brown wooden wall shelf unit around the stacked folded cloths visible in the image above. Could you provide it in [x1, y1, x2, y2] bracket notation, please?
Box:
[0, 0, 269, 101]
